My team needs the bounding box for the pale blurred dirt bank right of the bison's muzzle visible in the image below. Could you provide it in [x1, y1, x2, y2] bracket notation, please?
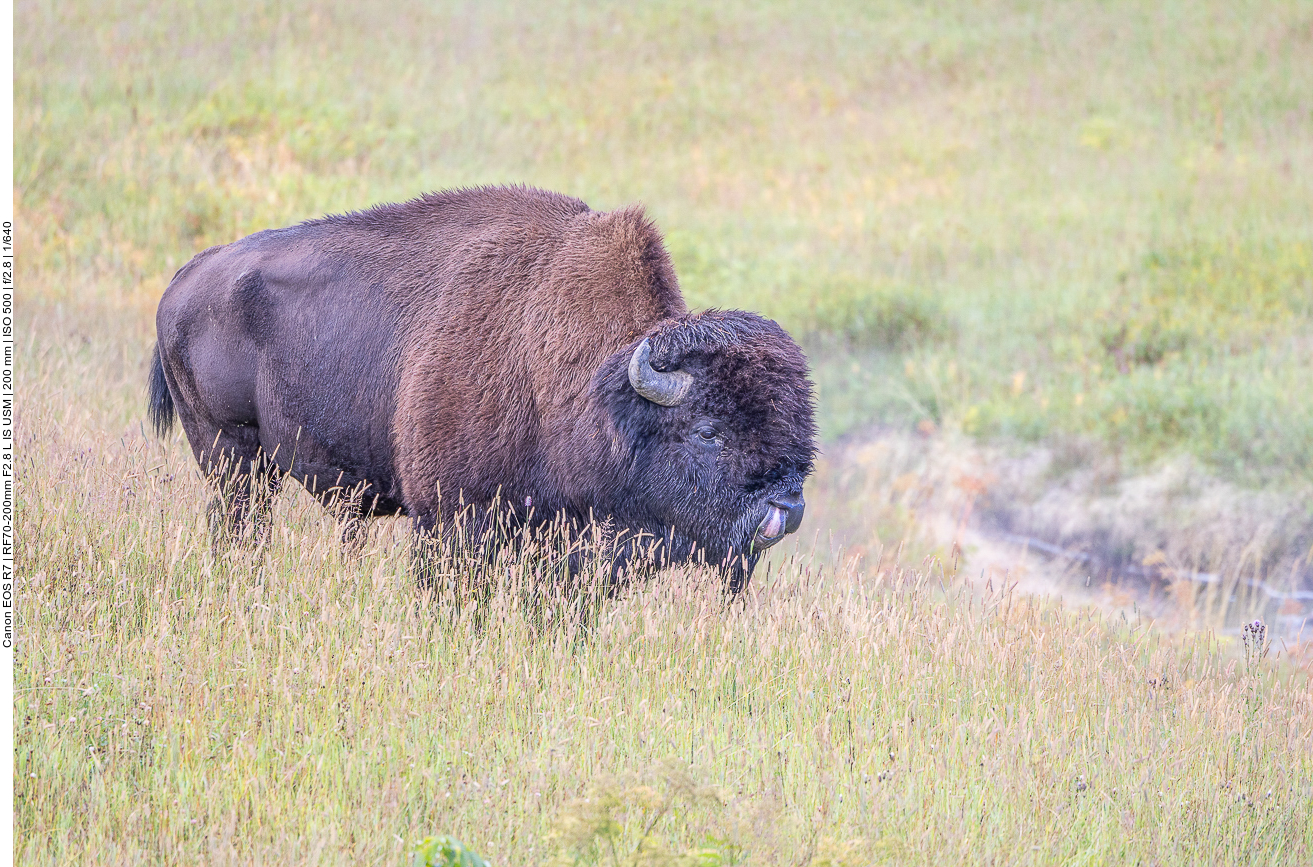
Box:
[809, 431, 1313, 637]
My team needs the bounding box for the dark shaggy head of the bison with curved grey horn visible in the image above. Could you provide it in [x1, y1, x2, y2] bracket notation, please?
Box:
[599, 310, 815, 590]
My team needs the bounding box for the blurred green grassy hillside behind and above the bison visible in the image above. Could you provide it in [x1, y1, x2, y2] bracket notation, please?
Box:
[14, 3, 1313, 481]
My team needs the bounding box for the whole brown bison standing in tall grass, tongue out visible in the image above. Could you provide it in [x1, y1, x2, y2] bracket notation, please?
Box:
[150, 187, 815, 591]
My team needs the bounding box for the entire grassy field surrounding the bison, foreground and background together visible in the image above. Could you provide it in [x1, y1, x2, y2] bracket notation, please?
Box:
[14, 0, 1313, 867]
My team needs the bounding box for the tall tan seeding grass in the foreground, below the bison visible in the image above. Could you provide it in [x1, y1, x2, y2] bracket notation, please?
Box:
[16, 338, 1313, 864]
